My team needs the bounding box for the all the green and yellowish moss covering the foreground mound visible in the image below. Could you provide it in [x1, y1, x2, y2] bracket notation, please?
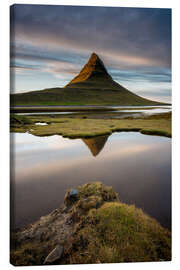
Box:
[64, 182, 171, 264]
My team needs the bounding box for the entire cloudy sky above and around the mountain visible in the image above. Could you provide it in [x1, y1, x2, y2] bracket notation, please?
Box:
[10, 5, 172, 102]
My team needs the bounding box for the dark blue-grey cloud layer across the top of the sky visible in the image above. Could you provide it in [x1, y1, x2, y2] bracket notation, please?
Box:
[11, 5, 171, 66]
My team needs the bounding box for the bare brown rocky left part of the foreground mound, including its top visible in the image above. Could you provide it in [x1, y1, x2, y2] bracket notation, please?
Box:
[11, 182, 118, 265]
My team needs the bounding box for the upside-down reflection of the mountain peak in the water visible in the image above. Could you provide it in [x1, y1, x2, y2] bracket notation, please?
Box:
[82, 135, 109, 157]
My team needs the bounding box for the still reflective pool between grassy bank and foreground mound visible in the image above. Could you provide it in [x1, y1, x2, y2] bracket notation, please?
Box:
[11, 132, 171, 228]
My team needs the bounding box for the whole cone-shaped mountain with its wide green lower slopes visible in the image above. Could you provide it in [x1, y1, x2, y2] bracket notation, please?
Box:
[11, 53, 167, 106]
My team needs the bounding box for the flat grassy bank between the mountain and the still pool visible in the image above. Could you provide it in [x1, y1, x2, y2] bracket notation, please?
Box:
[11, 113, 171, 138]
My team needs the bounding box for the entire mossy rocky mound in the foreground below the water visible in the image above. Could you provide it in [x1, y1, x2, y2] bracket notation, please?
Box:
[11, 182, 171, 265]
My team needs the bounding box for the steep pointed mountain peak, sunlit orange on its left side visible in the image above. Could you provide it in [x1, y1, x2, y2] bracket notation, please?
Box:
[66, 53, 112, 87]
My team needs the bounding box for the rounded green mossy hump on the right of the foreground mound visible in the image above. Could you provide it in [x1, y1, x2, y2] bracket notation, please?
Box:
[68, 202, 171, 264]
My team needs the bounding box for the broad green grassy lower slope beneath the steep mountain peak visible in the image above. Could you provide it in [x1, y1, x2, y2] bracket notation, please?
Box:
[11, 85, 167, 106]
